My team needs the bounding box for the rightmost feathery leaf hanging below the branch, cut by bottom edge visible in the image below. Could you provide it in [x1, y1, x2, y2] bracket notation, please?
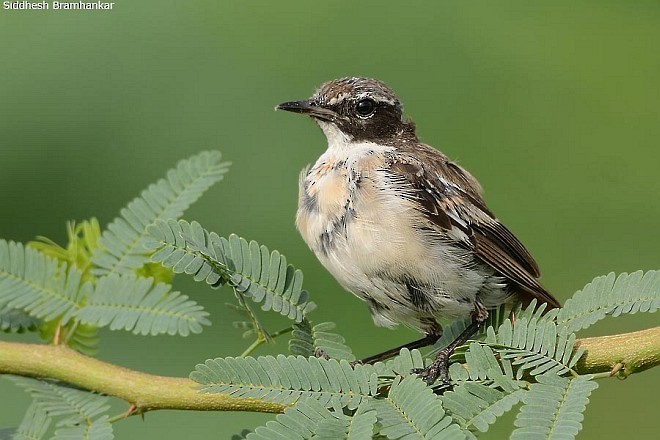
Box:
[511, 374, 598, 440]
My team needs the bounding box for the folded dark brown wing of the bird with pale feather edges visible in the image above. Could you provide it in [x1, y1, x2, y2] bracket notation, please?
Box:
[389, 146, 560, 307]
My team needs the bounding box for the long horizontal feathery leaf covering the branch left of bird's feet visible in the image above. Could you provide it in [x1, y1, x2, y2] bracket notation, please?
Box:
[190, 355, 378, 409]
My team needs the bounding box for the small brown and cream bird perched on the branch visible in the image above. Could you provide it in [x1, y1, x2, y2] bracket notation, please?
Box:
[276, 77, 560, 385]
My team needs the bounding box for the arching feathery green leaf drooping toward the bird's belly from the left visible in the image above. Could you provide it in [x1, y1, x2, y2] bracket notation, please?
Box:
[147, 220, 315, 322]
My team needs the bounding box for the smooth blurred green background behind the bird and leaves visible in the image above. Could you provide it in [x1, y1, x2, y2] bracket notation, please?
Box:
[0, 0, 660, 439]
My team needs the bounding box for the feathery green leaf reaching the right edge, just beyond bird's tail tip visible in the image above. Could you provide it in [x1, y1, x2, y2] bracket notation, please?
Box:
[557, 270, 660, 332]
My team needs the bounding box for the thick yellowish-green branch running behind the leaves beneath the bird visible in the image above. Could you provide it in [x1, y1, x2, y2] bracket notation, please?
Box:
[0, 327, 660, 413]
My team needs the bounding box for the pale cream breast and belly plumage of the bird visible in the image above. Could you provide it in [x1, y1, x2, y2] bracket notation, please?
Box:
[296, 143, 502, 329]
